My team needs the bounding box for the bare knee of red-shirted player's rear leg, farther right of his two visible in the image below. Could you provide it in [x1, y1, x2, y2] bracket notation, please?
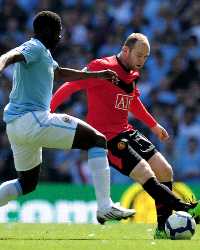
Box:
[148, 152, 173, 182]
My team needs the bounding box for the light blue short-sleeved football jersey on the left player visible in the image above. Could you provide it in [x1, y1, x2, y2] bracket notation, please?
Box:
[4, 38, 58, 123]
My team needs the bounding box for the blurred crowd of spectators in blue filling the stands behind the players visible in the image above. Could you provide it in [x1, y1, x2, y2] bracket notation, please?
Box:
[0, 0, 200, 184]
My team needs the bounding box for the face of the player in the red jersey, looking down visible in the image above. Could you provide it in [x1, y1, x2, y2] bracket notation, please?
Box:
[126, 41, 150, 70]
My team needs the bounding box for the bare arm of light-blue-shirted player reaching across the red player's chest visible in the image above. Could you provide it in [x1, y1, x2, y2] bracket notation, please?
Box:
[55, 67, 118, 82]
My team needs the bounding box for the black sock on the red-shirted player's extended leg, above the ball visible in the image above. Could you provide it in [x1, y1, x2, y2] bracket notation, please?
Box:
[143, 177, 189, 211]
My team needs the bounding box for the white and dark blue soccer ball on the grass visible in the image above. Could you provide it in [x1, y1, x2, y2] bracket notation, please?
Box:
[165, 211, 196, 240]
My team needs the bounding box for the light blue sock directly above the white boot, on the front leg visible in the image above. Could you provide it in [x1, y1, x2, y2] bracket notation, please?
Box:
[88, 147, 113, 211]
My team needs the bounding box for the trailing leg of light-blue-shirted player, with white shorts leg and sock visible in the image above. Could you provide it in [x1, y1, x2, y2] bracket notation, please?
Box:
[0, 116, 42, 206]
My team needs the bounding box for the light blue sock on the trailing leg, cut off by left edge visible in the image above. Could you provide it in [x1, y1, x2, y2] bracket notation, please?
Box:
[0, 179, 22, 206]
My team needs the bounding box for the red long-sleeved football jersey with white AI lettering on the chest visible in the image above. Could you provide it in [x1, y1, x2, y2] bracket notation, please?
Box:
[51, 56, 156, 140]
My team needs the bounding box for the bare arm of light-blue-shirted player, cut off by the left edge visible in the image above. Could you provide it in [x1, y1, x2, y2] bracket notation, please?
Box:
[0, 49, 25, 74]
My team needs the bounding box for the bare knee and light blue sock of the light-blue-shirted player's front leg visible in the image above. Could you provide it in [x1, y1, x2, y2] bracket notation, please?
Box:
[72, 122, 112, 210]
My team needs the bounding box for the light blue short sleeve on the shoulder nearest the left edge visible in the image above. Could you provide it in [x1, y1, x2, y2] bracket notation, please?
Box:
[16, 42, 42, 64]
